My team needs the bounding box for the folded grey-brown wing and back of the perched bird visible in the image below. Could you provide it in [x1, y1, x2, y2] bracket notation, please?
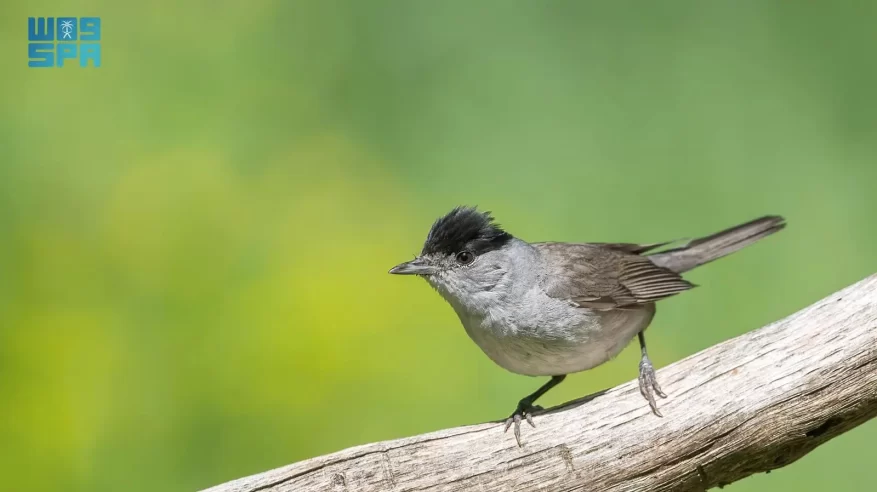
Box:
[533, 243, 694, 310]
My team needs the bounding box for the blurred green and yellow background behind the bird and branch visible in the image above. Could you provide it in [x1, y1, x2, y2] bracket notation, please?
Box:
[0, 0, 877, 492]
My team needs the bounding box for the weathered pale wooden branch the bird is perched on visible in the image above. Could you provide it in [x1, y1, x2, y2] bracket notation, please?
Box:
[202, 275, 877, 492]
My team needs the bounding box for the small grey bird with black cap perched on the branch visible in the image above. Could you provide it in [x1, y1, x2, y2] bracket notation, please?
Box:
[390, 207, 785, 446]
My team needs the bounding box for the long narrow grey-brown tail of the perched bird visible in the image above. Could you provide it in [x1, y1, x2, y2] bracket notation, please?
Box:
[649, 215, 786, 273]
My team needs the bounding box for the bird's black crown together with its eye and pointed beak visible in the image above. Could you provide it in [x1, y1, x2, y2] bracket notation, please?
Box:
[390, 206, 512, 275]
